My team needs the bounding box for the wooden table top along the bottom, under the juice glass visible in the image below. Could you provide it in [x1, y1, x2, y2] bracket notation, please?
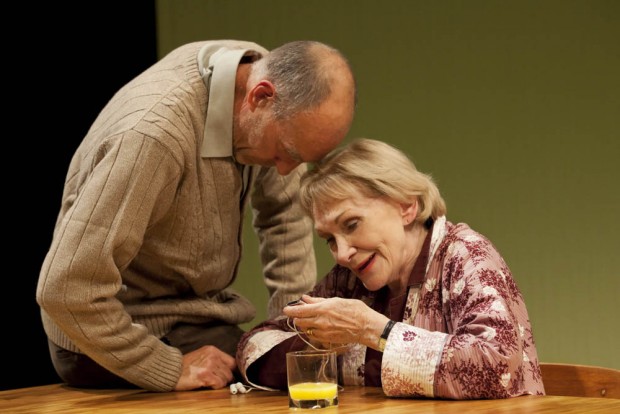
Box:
[0, 384, 620, 414]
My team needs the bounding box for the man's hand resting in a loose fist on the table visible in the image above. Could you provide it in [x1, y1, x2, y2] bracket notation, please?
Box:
[174, 345, 237, 391]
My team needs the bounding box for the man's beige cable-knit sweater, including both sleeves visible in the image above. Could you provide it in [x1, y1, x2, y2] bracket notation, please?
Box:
[37, 41, 316, 391]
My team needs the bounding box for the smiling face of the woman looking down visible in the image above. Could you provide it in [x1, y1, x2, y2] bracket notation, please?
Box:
[313, 196, 415, 291]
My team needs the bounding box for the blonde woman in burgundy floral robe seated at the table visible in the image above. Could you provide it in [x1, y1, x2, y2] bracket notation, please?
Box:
[237, 139, 544, 399]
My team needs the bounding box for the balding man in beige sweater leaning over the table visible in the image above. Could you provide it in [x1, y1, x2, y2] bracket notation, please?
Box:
[37, 40, 356, 392]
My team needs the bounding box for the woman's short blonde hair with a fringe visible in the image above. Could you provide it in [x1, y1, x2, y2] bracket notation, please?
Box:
[299, 138, 446, 223]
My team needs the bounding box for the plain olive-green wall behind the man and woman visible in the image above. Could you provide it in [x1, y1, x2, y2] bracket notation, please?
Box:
[157, 0, 620, 369]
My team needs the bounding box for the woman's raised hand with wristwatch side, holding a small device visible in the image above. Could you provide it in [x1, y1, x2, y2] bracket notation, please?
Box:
[283, 295, 389, 349]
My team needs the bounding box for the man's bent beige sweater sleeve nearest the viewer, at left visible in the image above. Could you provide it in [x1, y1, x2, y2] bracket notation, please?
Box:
[37, 131, 182, 391]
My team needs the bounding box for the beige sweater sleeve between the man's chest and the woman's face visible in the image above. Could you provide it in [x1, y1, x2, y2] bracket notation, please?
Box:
[252, 164, 317, 318]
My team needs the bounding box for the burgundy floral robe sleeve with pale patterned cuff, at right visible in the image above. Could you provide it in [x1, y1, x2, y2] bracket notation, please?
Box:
[381, 233, 543, 399]
